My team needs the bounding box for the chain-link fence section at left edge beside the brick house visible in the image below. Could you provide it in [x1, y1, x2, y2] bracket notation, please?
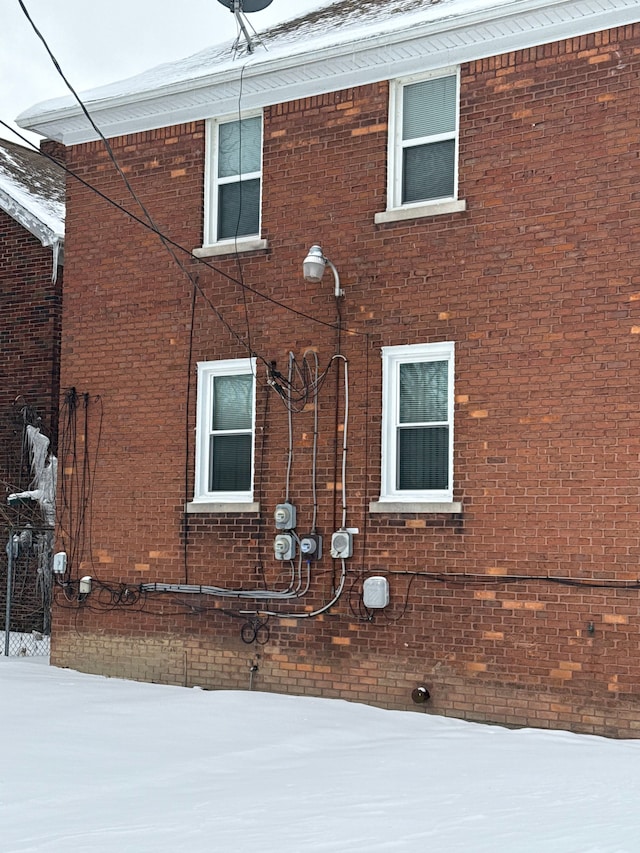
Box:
[0, 525, 53, 657]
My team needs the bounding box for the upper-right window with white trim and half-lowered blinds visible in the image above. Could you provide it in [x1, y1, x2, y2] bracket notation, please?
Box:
[388, 70, 459, 215]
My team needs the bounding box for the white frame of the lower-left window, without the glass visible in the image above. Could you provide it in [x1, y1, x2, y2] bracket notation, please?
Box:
[193, 358, 256, 504]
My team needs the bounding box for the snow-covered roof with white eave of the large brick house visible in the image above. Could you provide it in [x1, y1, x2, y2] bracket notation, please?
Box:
[18, 0, 638, 144]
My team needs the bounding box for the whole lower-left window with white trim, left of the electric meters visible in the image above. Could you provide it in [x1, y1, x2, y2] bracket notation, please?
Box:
[194, 358, 255, 503]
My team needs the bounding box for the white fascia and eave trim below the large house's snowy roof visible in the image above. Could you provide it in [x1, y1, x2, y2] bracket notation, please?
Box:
[20, 0, 640, 145]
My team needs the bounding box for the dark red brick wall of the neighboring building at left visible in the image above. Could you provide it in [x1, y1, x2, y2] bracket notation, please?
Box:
[0, 211, 62, 482]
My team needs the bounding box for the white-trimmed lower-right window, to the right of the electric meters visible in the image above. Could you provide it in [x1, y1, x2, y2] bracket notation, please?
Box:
[380, 342, 454, 502]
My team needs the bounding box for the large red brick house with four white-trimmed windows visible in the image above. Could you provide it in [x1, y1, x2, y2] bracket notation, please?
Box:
[21, 0, 640, 736]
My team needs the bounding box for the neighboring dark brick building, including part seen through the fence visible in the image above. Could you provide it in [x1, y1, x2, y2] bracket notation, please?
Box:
[0, 139, 65, 653]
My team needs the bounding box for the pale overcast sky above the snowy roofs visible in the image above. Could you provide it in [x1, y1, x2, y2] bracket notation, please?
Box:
[0, 0, 327, 142]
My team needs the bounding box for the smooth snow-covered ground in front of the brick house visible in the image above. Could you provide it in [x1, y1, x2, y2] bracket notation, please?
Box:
[0, 658, 640, 853]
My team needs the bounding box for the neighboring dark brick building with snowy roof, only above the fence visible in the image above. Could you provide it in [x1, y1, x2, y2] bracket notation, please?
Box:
[0, 139, 65, 472]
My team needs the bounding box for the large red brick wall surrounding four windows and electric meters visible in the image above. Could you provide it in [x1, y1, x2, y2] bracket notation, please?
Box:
[53, 25, 640, 736]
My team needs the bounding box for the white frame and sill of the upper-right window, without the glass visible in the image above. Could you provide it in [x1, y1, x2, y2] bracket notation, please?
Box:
[375, 67, 466, 223]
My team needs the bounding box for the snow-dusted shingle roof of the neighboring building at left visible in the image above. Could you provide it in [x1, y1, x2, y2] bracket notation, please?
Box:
[0, 139, 65, 241]
